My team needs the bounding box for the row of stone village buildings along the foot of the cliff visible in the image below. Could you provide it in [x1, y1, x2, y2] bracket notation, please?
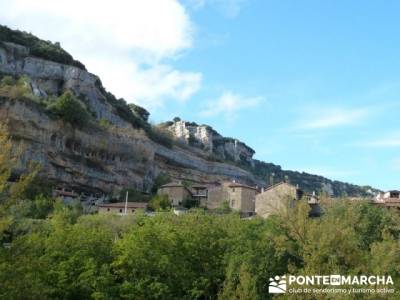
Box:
[53, 180, 400, 218]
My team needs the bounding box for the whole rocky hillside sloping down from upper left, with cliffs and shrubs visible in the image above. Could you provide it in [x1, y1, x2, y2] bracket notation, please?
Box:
[0, 26, 375, 196]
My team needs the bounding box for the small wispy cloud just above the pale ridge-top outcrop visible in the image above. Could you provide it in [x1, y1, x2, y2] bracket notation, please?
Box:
[200, 91, 264, 119]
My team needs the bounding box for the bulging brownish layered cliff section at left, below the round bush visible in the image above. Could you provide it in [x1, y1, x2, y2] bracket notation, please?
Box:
[0, 100, 154, 193]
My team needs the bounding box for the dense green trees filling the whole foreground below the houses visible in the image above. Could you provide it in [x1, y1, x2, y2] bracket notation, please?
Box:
[0, 126, 400, 300]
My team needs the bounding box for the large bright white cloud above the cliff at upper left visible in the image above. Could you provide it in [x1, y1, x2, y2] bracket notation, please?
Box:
[0, 0, 201, 108]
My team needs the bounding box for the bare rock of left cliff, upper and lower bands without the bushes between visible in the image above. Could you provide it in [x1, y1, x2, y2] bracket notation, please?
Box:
[0, 43, 259, 197]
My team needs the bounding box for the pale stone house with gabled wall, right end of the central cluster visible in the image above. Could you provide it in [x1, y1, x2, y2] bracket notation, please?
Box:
[255, 182, 322, 218]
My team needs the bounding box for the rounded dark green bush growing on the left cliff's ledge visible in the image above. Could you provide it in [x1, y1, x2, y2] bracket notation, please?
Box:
[49, 92, 89, 127]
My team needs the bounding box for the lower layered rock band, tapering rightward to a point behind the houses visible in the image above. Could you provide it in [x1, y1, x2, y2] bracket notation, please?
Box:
[0, 100, 260, 197]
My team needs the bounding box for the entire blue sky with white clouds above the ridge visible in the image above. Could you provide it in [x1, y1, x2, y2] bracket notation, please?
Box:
[0, 0, 400, 190]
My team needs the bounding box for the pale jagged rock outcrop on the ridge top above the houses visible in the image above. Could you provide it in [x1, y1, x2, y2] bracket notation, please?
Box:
[166, 120, 255, 166]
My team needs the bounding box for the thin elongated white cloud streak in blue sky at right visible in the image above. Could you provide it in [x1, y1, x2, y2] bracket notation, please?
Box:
[296, 108, 370, 129]
